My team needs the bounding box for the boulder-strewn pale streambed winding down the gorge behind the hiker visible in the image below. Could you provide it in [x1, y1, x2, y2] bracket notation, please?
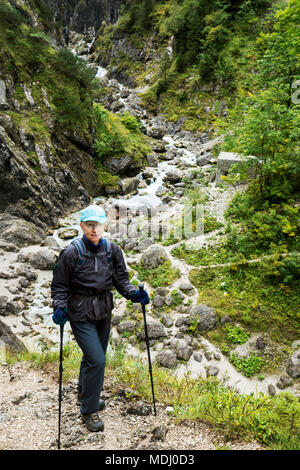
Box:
[0, 31, 299, 402]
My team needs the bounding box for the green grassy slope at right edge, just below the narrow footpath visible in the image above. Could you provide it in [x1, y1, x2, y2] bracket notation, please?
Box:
[190, 260, 300, 344]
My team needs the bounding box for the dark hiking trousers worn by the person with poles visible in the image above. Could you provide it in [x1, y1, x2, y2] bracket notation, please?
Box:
[71, 315, 111, 414]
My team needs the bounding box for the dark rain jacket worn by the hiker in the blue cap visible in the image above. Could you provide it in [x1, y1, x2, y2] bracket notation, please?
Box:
[51, 237, 136, 322]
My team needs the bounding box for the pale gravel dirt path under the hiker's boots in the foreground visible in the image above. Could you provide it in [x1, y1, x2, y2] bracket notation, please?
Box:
[0, 362, 263, 450]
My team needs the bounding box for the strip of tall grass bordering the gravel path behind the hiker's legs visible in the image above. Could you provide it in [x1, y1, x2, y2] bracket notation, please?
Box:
[5, 342, 300, 450]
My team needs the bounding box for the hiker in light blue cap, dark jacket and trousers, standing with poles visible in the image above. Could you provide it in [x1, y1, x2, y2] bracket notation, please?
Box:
[51, 205, 149, 431]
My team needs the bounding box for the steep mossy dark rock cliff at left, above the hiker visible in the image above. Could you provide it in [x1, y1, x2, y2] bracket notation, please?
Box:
[0, 0, 110, 241]
